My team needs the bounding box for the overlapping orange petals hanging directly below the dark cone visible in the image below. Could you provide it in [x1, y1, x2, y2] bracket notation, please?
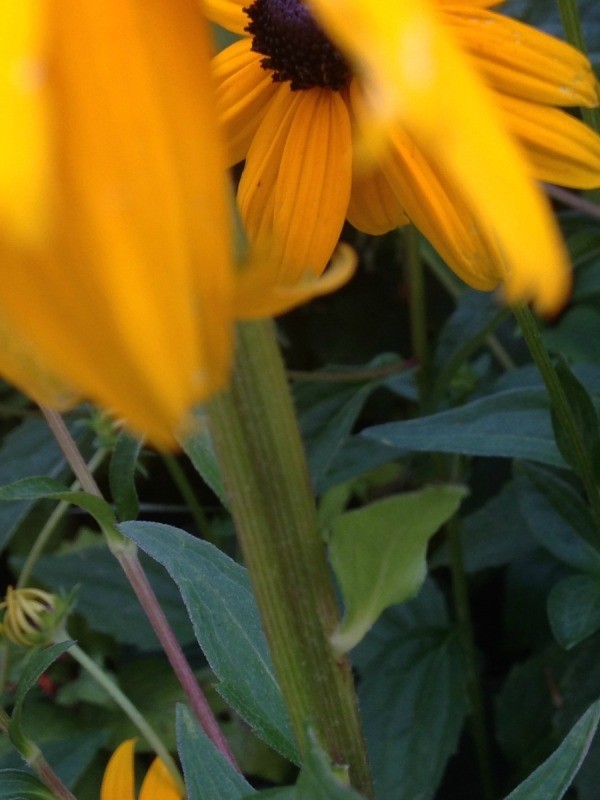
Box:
[239, 85, 352, 284]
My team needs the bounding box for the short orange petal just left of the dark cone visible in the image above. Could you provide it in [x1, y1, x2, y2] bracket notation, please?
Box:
[212, 38, 276, 166]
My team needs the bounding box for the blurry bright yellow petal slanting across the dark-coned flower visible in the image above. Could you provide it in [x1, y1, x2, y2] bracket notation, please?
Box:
[311, 0, 570, 313]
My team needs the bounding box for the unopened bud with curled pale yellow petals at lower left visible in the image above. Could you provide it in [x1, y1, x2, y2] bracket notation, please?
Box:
[0, 586, 70, 647]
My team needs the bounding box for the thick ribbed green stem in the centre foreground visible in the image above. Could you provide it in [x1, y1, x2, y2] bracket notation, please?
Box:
[208, 321, 373, 798]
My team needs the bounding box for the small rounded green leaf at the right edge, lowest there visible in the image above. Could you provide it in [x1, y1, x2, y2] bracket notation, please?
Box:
[548, 575, 600, 650]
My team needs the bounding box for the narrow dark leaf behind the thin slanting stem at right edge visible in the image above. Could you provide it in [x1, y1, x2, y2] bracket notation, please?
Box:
[551, 358, 600, 477]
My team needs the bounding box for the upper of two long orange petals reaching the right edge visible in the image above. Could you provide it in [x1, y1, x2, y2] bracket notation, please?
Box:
[443, 2, 600, 107]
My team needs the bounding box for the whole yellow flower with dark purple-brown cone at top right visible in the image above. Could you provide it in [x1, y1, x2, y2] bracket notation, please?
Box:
[204, 0, 600, 312]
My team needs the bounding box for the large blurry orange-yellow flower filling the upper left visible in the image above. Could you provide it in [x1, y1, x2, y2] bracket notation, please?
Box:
[0, 0, 234, 446]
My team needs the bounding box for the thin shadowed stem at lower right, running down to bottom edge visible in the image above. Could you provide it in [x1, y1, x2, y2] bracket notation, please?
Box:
[446, 517, 495, 800]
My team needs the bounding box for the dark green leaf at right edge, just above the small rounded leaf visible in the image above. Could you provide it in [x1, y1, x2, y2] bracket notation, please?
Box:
[515, 464, 600, 576]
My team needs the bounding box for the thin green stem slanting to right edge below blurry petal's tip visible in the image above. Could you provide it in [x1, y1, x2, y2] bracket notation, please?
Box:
[513, 306, 600, 534]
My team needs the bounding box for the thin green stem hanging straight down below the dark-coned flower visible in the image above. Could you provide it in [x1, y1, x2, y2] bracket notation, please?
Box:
[404, 225, 429, 402]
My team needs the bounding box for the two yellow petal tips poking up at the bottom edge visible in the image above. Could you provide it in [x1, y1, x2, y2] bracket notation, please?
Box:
[100, 739, 182, 800]
